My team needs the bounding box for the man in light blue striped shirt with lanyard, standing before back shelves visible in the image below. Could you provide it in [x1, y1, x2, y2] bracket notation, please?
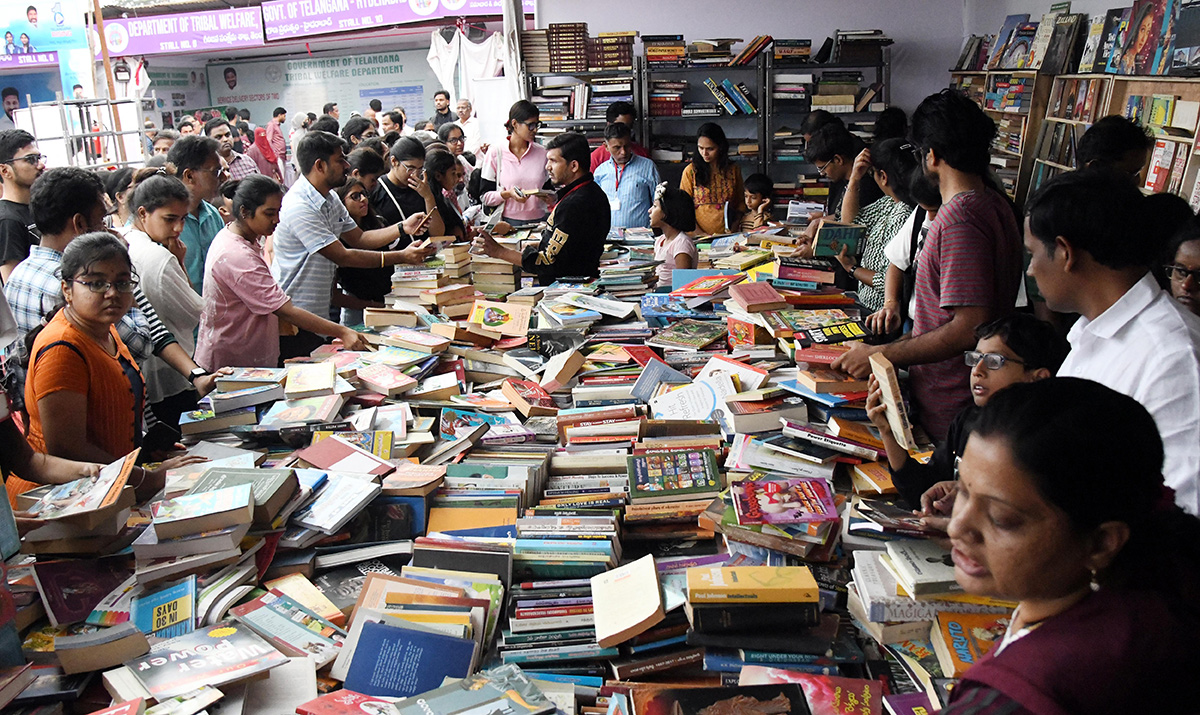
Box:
[595, 122, 659, 228]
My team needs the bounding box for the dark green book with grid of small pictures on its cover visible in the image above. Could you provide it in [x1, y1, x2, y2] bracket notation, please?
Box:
[625, 450, 721, 504]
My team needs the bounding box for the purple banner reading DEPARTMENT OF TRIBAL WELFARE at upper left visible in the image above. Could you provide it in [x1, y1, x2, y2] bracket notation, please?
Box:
[104, 7, 263, 56]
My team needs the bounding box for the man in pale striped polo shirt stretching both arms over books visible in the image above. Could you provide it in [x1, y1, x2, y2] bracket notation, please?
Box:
[271, 132, 436, 360]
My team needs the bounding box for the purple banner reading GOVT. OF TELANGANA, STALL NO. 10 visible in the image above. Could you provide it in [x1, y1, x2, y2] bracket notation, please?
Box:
[263, 0, 534, 42]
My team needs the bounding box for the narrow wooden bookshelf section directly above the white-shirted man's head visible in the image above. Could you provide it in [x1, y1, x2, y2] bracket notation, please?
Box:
[1030, 74, 1111, 193]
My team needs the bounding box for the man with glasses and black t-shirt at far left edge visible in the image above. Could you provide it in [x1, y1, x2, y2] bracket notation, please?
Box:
[0, 130, 46, 283]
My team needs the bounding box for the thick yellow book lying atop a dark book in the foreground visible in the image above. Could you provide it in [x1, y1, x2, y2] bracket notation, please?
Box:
[688, 566, 818, 603]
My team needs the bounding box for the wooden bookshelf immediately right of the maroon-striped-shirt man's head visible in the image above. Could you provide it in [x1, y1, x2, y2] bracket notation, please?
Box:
[950, 70, 1052, 208]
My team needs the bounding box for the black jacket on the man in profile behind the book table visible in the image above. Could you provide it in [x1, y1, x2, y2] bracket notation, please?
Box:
[521, 174, 611, 286]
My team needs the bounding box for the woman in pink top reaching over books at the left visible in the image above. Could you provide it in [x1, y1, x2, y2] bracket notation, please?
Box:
[196, 175, 368, 369]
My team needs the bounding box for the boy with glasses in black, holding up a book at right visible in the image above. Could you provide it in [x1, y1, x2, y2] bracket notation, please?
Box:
[866, 313, 1067, 525]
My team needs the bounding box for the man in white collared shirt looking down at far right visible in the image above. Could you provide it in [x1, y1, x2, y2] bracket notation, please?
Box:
[1025, 170, 1200, 515]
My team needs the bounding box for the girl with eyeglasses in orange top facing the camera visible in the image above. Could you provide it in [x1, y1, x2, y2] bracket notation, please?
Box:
[25, 232, 200, 498]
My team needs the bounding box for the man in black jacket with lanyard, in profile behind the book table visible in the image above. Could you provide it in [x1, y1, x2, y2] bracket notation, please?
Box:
[474, 132, 610, 286]
